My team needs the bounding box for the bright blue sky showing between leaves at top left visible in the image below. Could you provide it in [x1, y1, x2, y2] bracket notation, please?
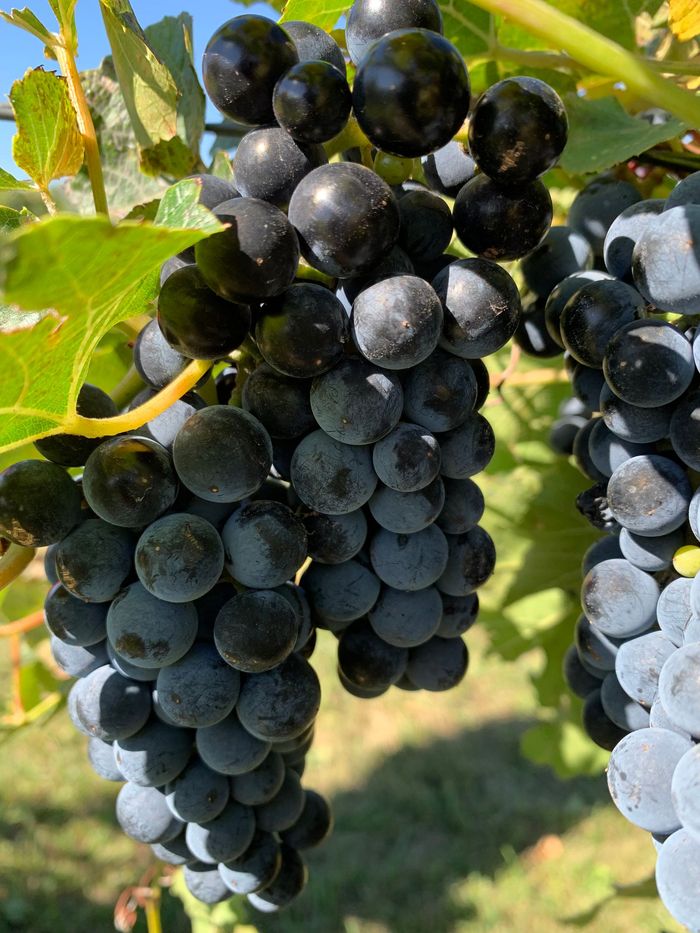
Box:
[0, 0, 277, 172]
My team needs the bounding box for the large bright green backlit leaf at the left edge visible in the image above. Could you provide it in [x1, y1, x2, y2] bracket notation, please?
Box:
[0, 181, 221, 450]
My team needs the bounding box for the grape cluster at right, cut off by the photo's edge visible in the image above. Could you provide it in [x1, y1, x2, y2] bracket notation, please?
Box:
[523, 173, 700, 930]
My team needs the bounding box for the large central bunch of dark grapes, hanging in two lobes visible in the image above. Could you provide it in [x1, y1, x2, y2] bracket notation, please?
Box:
[0, 0, 567, 911]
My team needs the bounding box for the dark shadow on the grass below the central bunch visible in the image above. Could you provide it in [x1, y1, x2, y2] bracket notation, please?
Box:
[250, 720, 608, 933]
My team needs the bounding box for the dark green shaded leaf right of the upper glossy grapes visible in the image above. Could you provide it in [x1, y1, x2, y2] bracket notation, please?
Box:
[559, 95, 685, 174]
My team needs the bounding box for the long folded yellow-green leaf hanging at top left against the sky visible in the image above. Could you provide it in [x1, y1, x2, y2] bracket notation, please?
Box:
[100, 0, 179, 160]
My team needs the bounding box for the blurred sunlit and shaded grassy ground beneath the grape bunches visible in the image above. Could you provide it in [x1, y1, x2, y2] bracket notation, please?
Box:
[0, 631, 680, 933]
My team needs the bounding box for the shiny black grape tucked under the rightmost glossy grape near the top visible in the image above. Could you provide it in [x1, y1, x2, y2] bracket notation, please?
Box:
[453, 175, 552, 261]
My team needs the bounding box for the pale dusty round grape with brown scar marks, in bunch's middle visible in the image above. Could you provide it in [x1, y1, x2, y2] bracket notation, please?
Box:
[351, 275, 443, 370]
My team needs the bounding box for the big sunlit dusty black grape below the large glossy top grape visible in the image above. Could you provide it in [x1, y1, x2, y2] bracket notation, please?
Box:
[289, 162, 399, 278]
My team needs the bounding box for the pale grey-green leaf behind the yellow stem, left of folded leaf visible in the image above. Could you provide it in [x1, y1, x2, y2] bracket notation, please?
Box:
[61, 60, 167, 217]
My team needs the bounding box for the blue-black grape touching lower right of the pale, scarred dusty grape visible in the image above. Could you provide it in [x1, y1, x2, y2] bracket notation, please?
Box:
[404, 347, 476, 431]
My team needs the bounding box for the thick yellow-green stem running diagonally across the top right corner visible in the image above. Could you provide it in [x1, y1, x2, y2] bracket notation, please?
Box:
[464, 0, 700, 127]
